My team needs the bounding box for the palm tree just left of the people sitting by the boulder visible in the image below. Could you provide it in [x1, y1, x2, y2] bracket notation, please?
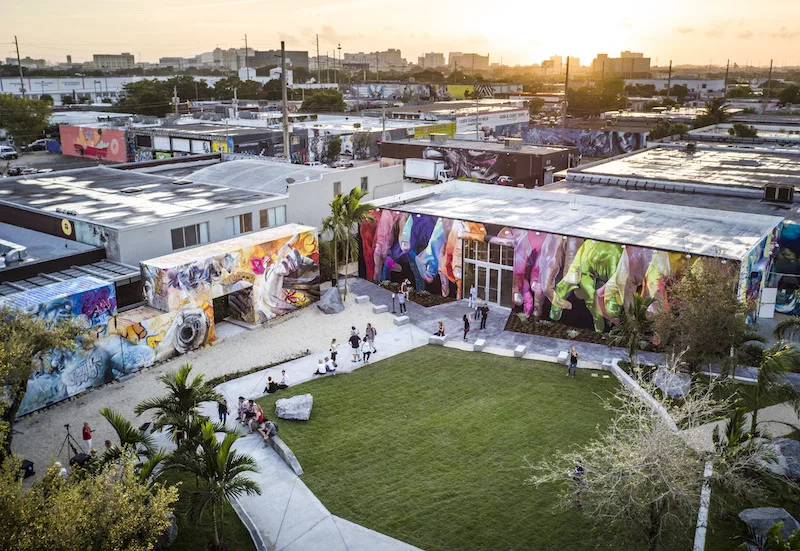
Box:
[134, 364, 222, 444]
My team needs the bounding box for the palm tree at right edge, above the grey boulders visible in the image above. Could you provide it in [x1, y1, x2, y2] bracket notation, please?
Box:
[750, 342, 800, 434]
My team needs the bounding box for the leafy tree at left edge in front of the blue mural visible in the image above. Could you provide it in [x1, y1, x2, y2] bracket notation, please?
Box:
[0, 306, 82, 460]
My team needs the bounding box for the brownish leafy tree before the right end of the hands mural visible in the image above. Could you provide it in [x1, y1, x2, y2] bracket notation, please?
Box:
[655, 259, 748, 373]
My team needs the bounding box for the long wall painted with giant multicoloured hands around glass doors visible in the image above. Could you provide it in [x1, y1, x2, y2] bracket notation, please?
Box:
[359, 210, 712, 331]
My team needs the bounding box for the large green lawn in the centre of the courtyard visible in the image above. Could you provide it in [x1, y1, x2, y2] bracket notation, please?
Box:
[260, 346, 617, 551]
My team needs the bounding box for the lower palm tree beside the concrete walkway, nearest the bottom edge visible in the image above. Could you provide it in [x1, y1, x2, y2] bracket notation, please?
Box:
[169, 422, 261, 548]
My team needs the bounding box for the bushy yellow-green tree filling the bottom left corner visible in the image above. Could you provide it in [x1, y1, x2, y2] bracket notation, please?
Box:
[0, 455, 178, 551]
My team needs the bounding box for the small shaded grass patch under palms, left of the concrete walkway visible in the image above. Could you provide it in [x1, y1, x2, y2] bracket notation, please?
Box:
[163, 471, 253, 551]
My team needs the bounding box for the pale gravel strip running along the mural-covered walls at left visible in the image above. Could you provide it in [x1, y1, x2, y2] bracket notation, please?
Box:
[6, 293, 394, 474]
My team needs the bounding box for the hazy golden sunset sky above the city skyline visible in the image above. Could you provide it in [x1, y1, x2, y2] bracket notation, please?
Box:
[6, 0, 800, 66]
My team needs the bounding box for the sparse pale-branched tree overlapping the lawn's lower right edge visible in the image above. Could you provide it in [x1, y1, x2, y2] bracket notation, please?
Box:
[529, 379, 770, 551]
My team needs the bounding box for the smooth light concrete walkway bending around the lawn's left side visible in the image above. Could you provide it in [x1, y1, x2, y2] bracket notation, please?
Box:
[203, 325, 428, 551]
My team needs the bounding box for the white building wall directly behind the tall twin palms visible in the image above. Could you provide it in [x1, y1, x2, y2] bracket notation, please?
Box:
[286, 163, 404, 229]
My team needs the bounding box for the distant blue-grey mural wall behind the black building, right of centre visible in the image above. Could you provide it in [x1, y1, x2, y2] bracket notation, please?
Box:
[521, 126, 647, 157]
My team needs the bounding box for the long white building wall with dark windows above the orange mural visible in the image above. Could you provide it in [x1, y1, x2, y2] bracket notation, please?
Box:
[111, 196, 290, 266]
